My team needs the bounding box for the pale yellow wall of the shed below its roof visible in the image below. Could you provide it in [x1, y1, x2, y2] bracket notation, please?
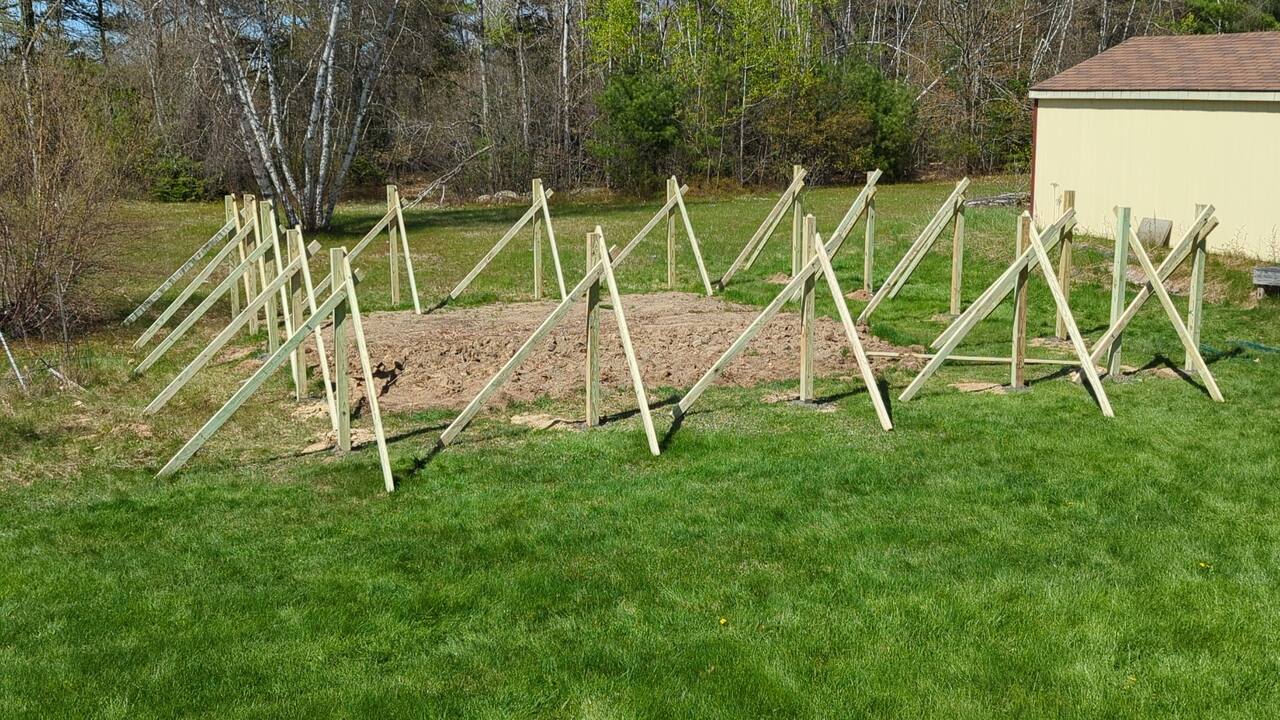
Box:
[1033, 99, 1280, 261]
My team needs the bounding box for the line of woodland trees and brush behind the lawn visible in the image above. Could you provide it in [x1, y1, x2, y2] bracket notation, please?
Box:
[0, 0, 1280, 335]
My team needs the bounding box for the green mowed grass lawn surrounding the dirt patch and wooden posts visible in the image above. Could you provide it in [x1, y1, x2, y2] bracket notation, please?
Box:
[0, 178, 1280, 719]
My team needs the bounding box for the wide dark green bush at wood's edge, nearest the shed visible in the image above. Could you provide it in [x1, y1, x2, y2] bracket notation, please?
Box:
[760, 63, 916, 182]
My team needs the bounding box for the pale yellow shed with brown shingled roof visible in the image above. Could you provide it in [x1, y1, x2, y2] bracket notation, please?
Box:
[1030, 32, 1280, 261]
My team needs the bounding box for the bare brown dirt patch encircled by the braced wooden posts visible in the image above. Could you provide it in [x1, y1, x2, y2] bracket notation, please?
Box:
[330, 292, 902, 410]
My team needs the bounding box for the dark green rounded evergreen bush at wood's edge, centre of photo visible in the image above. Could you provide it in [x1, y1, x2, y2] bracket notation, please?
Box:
[589, 70, 681, 190]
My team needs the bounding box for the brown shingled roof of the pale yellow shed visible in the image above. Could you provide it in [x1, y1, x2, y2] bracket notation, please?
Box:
[1032, 32, 1280, 92]
